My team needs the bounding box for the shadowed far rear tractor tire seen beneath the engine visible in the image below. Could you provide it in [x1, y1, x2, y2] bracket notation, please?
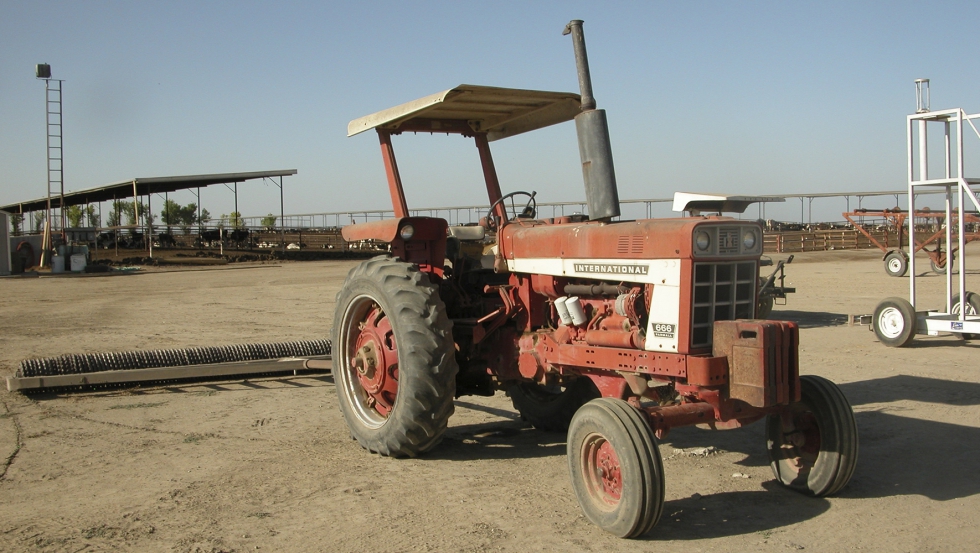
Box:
[508, 376, 601, 432]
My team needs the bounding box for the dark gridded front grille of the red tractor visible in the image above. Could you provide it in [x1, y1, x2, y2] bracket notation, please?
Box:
[691, 261, 759, 348]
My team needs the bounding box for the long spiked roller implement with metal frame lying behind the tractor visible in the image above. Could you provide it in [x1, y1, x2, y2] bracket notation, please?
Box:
[7, 340, 331, 391]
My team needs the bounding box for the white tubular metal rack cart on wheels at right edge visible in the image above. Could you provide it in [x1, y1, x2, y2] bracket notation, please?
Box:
[871, 79, 980, 347]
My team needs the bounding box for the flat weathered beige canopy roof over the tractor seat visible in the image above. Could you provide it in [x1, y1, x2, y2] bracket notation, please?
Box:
[347, 84, 582, 140]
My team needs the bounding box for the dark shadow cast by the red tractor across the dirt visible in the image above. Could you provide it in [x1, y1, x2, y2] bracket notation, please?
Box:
[438, 375, 980, 542]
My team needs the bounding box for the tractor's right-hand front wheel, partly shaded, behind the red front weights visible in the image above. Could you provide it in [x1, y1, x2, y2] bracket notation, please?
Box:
[766, 375, 858, 497]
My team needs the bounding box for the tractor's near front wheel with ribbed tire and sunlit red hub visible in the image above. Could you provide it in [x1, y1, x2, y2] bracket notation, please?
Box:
[568, 398, 664, 538]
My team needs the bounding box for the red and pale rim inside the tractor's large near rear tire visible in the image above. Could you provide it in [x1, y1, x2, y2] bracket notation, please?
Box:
[341, 295, 398, 428]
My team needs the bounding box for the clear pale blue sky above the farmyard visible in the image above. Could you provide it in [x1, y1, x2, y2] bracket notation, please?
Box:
[0, 0, 980, 223]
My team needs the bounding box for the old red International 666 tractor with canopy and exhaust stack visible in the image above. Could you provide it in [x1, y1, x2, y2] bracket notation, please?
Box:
[333, 21, 858, 537]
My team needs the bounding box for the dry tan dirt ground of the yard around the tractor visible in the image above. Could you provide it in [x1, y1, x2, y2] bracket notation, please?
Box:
[0, 247, 980, 552]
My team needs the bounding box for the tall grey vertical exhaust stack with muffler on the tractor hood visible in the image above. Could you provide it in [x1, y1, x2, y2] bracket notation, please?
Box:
[562, 19, 619, 221]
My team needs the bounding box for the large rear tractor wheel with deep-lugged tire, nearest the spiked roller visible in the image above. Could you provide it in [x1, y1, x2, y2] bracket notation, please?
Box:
[333, 256, 459, 457]
